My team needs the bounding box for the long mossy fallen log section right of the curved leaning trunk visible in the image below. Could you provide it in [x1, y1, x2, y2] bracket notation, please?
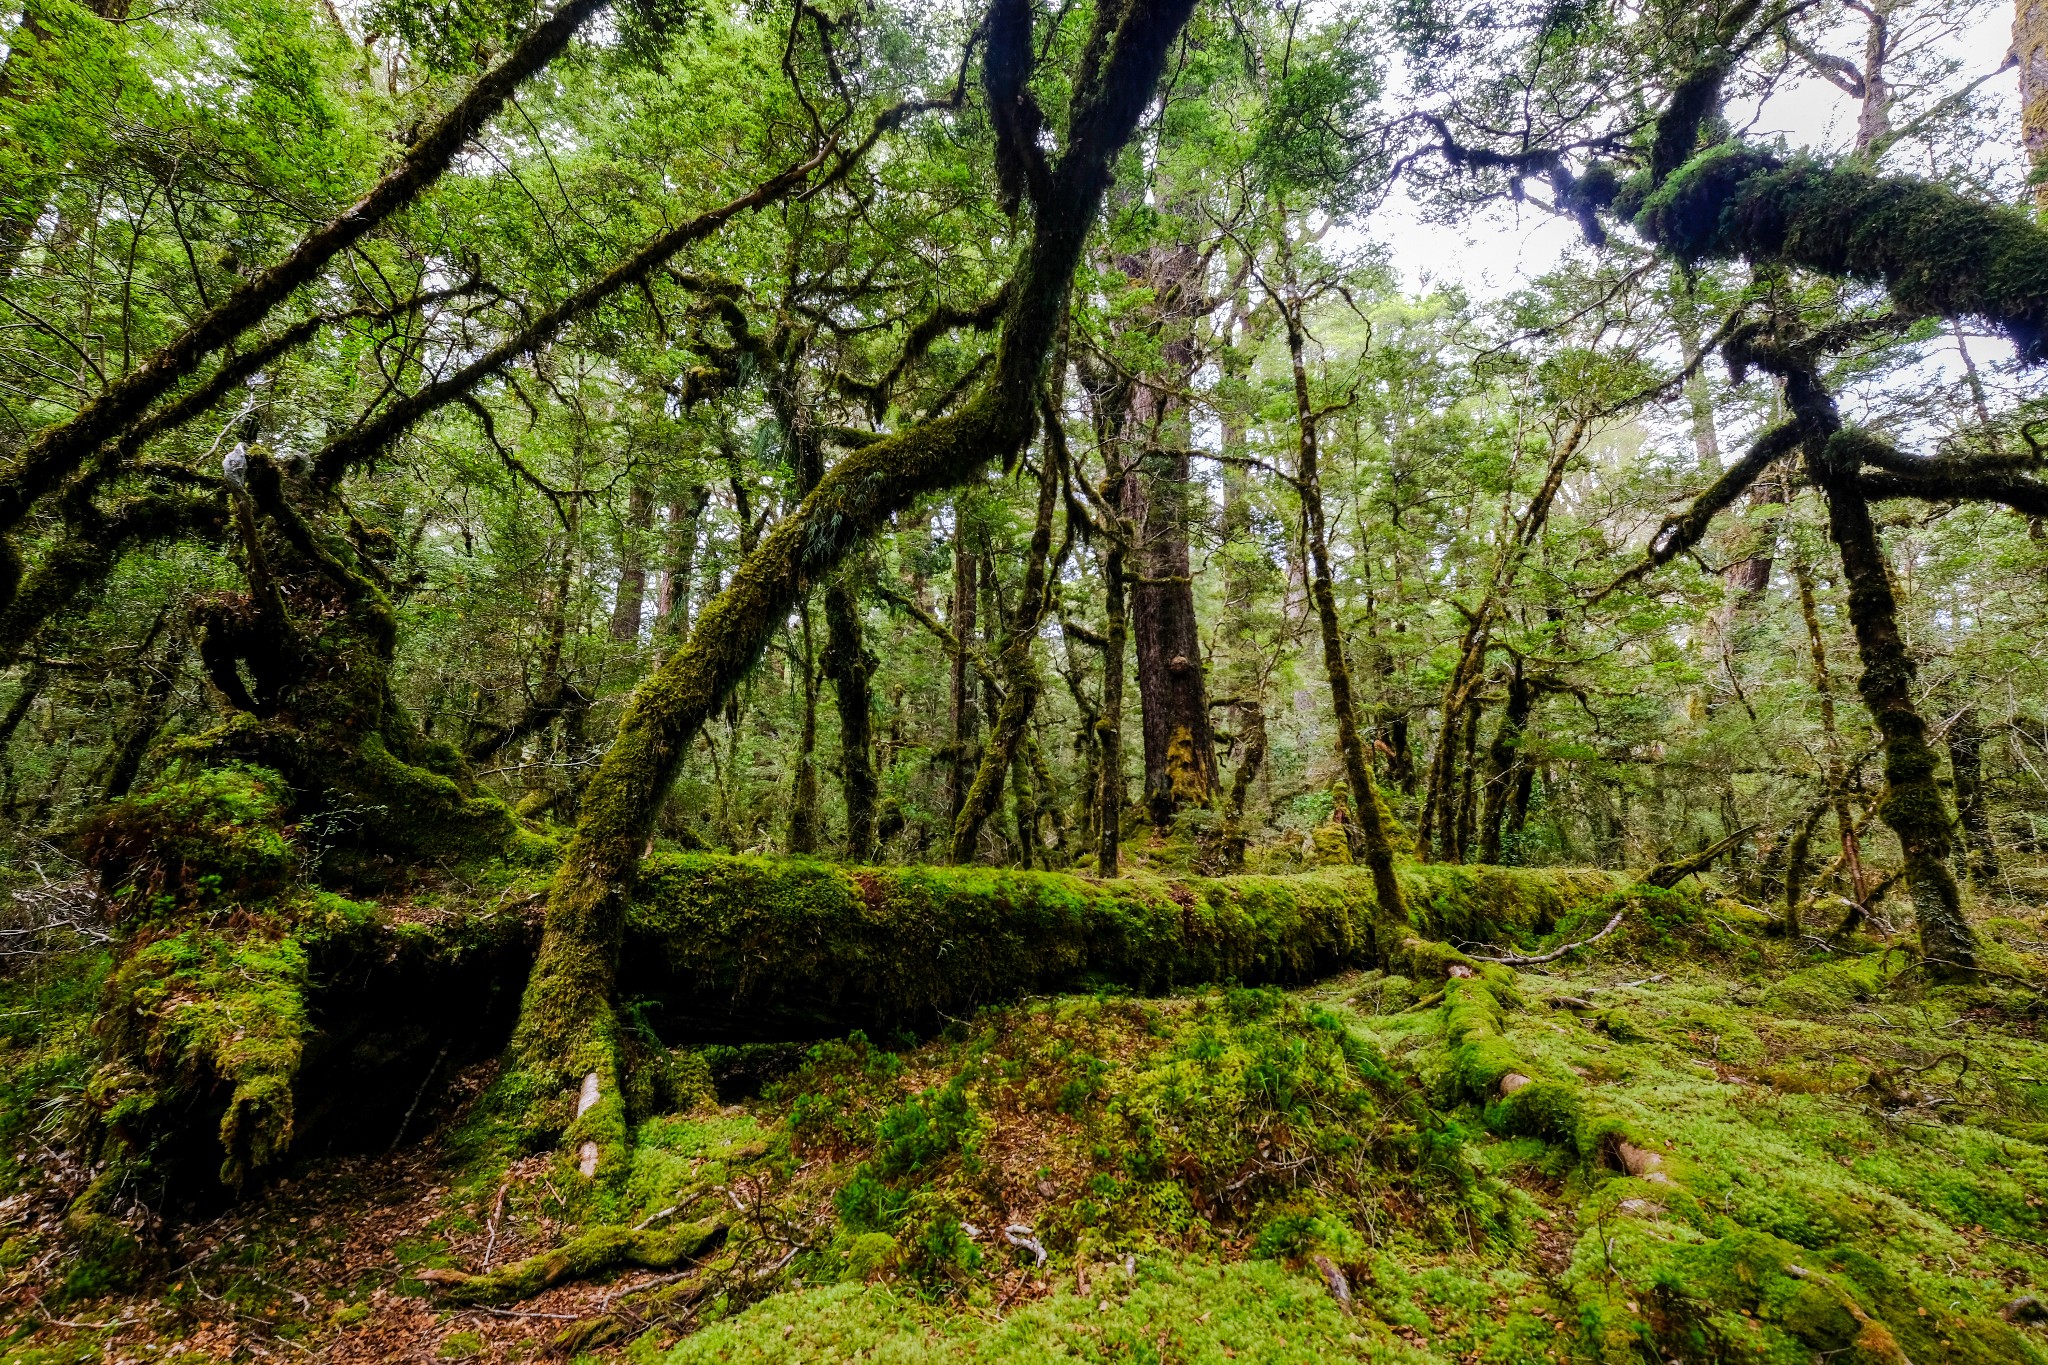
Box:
[621, 853, 1624, 1042]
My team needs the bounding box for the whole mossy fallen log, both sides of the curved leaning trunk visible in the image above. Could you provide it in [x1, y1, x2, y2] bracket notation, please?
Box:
[86, 853, 1624, 1199]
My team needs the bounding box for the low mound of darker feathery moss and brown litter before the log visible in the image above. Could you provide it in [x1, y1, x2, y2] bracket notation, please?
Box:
[776, 988, 1493, 1285]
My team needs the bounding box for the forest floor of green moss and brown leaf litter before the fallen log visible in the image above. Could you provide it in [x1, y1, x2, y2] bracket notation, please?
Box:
[0, 879, 2048, 1365]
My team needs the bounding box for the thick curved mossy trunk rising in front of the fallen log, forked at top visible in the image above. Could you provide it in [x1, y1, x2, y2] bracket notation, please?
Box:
[500, 0, 1192, 1175]
